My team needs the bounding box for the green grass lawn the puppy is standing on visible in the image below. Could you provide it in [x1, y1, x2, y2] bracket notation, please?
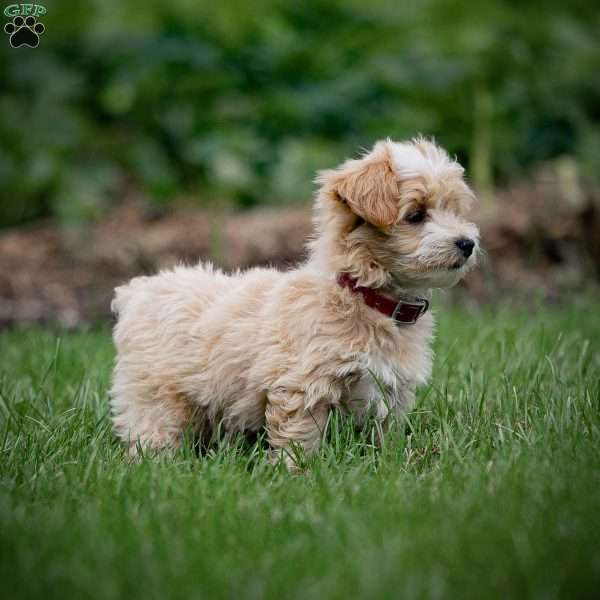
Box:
[0, 299, 600, 599]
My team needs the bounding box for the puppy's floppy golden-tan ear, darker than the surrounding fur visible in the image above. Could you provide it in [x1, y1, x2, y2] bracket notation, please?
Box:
[320, 144, 400, 227]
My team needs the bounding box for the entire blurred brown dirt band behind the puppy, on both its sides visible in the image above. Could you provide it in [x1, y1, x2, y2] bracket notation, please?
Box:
[0, 168, 600, 326]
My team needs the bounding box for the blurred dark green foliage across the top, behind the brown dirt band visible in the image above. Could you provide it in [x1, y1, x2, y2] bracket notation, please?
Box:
[0, 0, 600, 225]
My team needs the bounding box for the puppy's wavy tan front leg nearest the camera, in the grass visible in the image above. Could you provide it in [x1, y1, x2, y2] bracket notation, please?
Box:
[265, 390, 329, 468]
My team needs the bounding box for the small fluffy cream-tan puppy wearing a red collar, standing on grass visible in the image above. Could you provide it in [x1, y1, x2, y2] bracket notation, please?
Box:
[111, 138, 479, 462]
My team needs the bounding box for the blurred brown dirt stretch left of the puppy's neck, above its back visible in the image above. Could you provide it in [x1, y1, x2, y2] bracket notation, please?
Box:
[0, 202, 310, 326]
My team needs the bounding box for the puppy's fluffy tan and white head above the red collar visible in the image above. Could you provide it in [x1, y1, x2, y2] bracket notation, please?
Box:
[317, 139, 479, 287]
